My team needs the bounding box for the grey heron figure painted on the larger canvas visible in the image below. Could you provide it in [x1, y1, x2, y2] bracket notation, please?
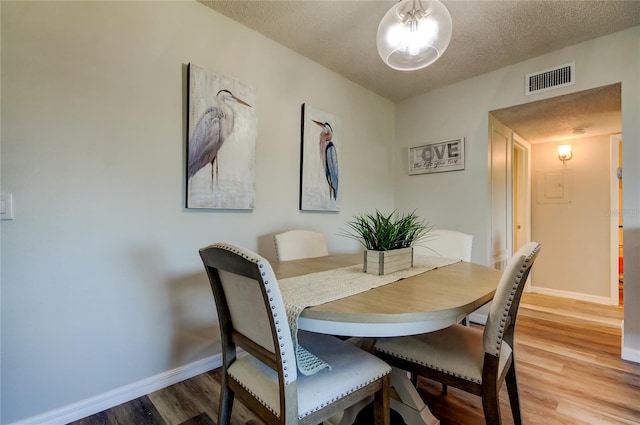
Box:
[187, 90, 251, 185]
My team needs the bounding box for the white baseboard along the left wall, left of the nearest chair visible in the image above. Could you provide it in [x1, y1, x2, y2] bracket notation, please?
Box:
[11, 354, 222, 425]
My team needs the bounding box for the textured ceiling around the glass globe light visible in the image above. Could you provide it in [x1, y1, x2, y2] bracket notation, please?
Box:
[199, 0, 640, 141]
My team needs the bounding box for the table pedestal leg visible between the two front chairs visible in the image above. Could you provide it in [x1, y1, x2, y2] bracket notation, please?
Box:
[391, 367, 440, 425]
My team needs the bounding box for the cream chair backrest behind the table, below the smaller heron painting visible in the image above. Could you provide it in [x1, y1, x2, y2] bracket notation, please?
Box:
[273, 230, 329, 261]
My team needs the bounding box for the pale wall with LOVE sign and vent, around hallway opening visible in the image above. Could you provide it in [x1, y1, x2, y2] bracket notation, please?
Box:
[394, 27, 640, 362]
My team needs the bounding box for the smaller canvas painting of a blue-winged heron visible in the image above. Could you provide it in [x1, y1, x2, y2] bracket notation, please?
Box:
[300, 104, 342, 211]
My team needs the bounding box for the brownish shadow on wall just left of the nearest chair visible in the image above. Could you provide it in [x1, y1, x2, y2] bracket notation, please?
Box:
[168, 269, 222, 368]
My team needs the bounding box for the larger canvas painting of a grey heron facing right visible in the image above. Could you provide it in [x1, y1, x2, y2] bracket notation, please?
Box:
[186, 64, 257, 209]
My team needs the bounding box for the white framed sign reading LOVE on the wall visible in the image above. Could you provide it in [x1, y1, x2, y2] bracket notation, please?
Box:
[409, 137, 464, 175]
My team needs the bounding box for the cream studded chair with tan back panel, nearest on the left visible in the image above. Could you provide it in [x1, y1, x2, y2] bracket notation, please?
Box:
[200, 244, 391, 425]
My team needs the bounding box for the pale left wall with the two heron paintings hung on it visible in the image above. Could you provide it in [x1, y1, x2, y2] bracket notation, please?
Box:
[0, 1, 394, 423]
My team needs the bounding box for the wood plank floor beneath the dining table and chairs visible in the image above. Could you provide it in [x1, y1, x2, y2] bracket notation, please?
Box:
[67, 294, 640, 425]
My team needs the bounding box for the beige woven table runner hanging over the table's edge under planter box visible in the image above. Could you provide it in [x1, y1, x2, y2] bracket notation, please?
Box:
[278, 255, 460, 375]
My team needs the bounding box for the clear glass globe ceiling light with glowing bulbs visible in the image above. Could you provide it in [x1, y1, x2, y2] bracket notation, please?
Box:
[376, 0, 453, 71]
